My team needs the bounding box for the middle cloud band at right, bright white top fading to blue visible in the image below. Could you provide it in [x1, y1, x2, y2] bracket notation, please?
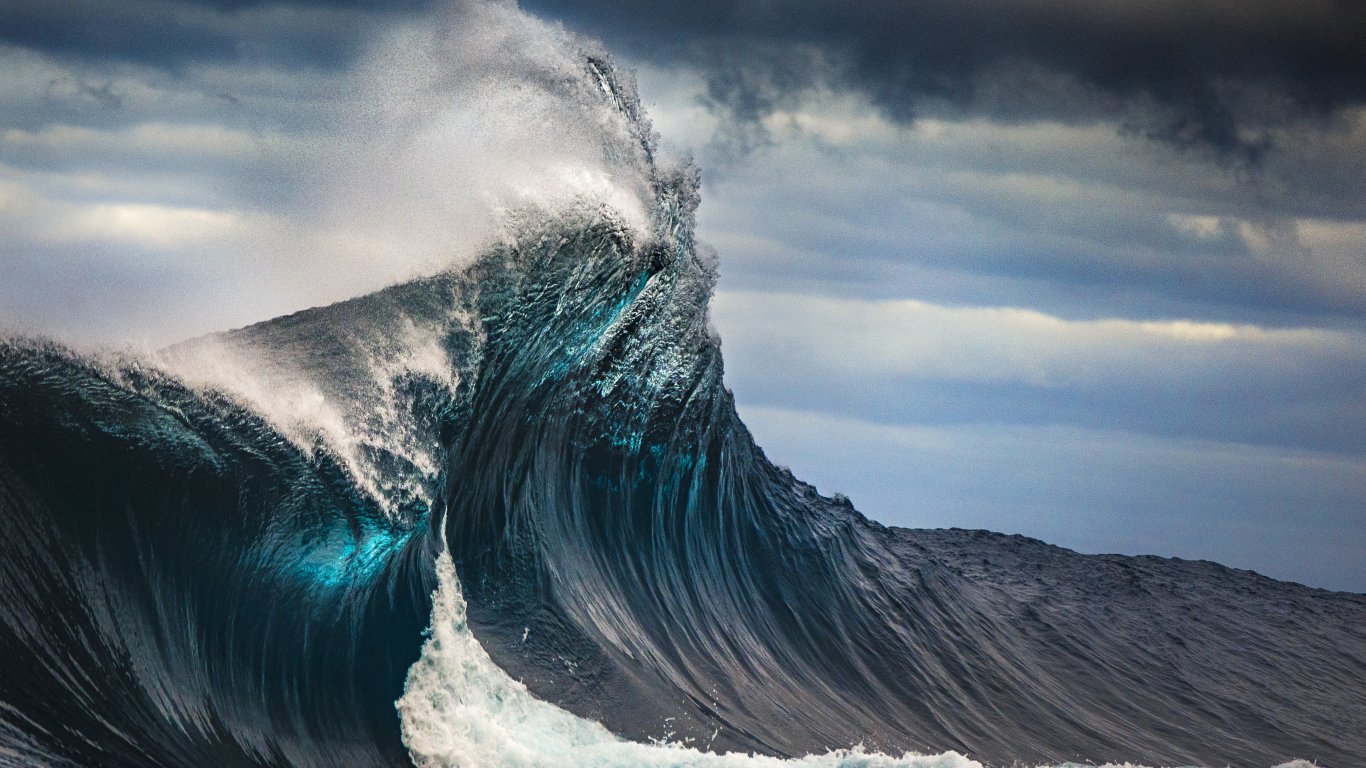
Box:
[714, 291, 1366, 456]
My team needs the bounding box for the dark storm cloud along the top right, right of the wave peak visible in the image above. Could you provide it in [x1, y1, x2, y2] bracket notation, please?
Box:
[523, 0, 1366, 160]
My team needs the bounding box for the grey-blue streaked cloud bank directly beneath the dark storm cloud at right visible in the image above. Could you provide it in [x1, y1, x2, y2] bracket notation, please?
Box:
[683, 102, 1366, 325]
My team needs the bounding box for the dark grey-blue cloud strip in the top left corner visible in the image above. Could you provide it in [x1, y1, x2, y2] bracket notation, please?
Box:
[0, 0, 432, 70]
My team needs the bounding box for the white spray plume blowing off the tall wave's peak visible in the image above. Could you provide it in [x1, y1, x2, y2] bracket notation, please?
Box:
[312, 0, 653, 286]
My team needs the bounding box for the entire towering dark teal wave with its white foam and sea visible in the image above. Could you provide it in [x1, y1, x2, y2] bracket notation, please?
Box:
[0, 59, 1366, 768]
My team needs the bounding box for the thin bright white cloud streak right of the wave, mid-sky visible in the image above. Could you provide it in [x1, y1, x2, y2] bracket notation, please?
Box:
[714, 291, 1363, 388]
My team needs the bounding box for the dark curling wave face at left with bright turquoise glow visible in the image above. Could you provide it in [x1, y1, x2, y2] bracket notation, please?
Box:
[0, 344, 434, 767]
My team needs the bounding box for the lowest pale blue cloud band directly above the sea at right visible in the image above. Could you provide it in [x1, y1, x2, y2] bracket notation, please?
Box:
[740, 403, 1366, 592]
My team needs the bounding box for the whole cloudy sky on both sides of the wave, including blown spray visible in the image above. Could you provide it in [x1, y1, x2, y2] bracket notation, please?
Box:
[0, 0, 1366, 592]
